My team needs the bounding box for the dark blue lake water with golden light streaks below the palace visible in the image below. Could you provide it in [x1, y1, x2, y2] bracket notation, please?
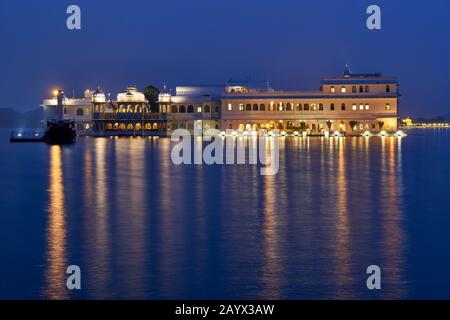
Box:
[0, 129, 450, 299]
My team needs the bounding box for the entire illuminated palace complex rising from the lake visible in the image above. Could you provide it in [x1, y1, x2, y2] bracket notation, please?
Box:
[43, 69, 399, 136]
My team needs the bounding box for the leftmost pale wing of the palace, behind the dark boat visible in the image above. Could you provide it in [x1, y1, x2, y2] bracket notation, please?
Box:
[42, 90, 92, 134]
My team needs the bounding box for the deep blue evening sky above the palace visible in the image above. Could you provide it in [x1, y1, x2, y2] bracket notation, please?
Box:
[0, 0, 450, 116]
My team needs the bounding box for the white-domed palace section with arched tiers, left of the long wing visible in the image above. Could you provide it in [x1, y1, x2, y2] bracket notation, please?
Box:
[92, 86, 166, 135]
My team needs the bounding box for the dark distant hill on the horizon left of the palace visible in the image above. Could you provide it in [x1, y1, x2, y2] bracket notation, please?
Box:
[0, 108, 44, 128]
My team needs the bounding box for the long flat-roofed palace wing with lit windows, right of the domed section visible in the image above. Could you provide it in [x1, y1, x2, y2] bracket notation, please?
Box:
[160, 69, 399, 134]
